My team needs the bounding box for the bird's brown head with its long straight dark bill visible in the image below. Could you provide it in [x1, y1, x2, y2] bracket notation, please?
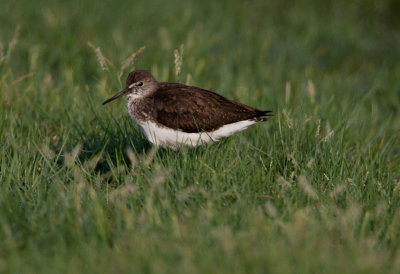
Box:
[103, 70, 157, 105]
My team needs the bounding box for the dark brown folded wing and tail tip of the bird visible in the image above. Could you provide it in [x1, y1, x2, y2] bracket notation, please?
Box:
[152, 83, 270, 133]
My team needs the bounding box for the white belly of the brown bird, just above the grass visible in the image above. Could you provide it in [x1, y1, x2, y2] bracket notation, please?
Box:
[134, 119, 256, 148]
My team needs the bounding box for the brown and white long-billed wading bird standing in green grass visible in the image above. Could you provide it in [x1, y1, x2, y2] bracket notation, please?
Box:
[103, 70, 272, 149]
